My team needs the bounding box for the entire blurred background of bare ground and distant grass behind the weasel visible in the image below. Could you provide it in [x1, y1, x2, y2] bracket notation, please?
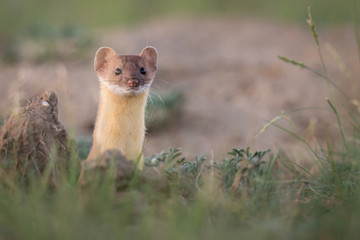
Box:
[0, 0, 360, 158]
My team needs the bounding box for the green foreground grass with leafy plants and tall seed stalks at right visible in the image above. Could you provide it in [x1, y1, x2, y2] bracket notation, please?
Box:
[0, 3, 360, 239]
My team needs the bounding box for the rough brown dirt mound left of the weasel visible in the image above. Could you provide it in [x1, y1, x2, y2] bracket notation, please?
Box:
[0, 92, 69, 178]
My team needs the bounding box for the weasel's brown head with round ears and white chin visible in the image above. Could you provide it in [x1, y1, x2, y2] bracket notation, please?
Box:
[94, 47, 157, 96]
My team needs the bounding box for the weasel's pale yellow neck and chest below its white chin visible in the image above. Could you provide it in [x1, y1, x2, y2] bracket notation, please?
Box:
[88, 83, 148, 164]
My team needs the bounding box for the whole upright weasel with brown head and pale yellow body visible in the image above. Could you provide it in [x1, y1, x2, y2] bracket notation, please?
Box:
[87, 47, 157, 168]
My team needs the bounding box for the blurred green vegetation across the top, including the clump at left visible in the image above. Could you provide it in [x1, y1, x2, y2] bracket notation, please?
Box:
[0, 0, 356, 63]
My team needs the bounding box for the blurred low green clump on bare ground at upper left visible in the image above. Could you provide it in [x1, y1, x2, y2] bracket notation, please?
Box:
[0, 23, 93, 64]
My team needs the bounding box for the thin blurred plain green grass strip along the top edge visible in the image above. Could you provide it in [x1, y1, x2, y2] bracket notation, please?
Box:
[0, 0, 356, 42]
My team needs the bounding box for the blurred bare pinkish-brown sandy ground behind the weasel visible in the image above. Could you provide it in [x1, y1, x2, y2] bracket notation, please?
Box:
[0, 19, 359, 157]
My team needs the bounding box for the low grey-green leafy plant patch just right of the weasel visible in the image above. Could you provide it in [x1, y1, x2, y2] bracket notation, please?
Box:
[145, 148, 270, 197]
